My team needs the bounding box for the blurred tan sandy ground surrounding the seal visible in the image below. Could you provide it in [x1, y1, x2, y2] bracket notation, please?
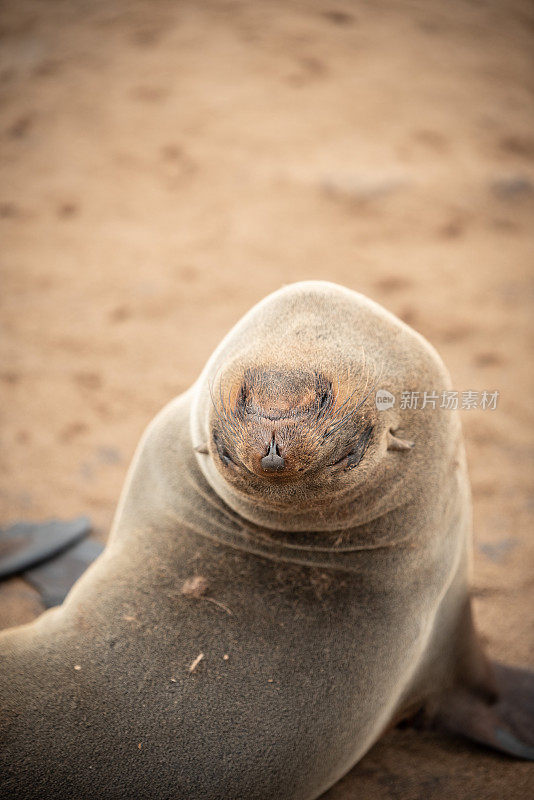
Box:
[0, 0, 534, 800]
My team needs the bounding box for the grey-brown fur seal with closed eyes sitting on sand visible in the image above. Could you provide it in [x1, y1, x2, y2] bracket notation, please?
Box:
[0, 282, 534, 800]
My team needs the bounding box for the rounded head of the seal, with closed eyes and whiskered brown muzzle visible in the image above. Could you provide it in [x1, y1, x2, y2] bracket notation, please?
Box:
[192, 283, 438, 530]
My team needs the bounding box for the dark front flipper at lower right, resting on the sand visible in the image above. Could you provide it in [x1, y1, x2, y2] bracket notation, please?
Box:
[427, 662, 534, 761]
